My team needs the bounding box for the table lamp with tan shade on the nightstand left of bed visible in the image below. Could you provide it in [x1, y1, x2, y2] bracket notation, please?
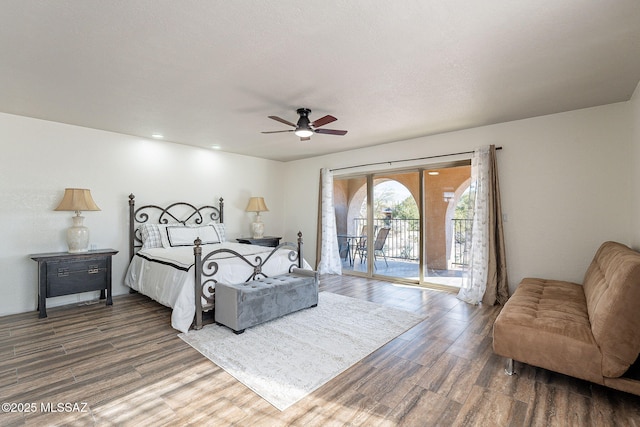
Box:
[54, 188, 100, 253]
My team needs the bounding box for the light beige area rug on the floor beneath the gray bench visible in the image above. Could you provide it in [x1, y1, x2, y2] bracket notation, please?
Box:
[178, 292, 423, 411]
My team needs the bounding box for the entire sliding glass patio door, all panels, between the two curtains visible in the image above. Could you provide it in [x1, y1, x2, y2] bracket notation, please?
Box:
[334, 161, 470, 286]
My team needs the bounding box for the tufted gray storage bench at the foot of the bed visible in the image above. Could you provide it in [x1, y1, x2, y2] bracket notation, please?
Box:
[215, 268, 318, 334]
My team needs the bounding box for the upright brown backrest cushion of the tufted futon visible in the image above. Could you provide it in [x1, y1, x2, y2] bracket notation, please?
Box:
[584, 242, 640, 378]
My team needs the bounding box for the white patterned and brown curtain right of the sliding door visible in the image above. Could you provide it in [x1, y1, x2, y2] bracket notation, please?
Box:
[458, 145, 509, 305]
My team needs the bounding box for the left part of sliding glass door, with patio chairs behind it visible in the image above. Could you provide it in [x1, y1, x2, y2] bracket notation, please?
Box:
[334, 171, 421, 283]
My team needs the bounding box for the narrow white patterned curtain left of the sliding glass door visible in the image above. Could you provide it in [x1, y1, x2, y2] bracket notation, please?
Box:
[316, 168, 342, 274]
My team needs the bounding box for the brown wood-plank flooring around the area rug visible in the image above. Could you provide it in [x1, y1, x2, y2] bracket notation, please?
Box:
[0, 276, 640, 426]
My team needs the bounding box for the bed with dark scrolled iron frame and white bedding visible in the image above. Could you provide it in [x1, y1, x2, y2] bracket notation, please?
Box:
[124, 194, 311, 332]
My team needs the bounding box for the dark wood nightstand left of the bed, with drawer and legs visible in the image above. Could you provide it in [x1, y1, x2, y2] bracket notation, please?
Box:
[29, 249, 118, 318]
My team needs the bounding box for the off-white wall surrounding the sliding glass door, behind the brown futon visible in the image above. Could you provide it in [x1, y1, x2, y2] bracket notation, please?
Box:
[285, 103, 638, 290]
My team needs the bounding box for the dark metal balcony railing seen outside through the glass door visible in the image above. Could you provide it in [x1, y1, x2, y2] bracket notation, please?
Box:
[351, 218, 472, 267]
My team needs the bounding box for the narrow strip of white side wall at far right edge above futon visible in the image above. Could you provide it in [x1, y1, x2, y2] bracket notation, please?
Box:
[629, 83, 640, 250]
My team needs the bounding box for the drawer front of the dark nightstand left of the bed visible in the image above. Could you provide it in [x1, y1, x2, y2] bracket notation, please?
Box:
[47, 257, 107, 297]
